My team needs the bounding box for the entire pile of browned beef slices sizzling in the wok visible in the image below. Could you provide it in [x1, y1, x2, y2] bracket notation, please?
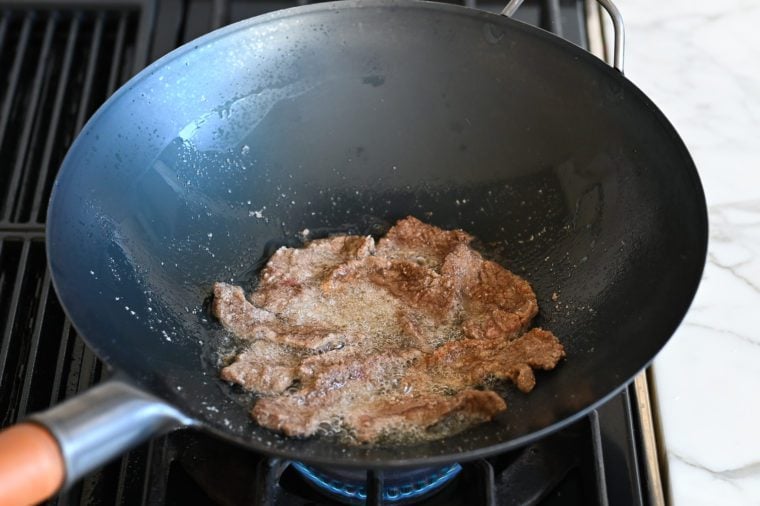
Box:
[213, 217, 564, 442]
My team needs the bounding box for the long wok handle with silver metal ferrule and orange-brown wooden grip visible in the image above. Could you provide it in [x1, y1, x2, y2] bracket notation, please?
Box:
[0, 380, 194, 506]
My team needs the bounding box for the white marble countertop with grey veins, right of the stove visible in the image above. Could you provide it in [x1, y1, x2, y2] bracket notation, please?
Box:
[616, 0, 760, 506]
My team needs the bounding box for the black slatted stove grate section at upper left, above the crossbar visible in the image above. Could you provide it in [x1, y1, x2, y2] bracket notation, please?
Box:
[0, 3, 144, 225]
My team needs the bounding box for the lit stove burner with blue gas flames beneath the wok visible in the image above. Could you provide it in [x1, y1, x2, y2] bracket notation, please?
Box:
[292, 462, 462, 504]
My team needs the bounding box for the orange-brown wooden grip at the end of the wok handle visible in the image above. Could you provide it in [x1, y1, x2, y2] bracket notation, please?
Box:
[0, 423, 66, 506]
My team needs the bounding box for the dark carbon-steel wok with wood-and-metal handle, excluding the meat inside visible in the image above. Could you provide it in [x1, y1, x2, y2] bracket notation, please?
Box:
[0, 0, 707, 504]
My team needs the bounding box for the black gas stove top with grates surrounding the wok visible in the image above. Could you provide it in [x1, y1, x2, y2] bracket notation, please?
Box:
[0, 0, 653, 506]
